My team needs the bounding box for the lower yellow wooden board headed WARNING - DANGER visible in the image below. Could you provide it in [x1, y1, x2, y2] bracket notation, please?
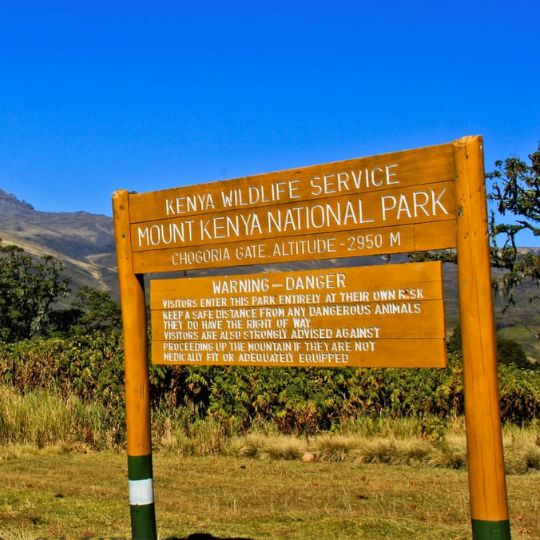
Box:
[150, 262, 446, 367]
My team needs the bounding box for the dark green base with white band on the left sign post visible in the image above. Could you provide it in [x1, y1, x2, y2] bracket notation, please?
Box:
[128, 454, 157, 540]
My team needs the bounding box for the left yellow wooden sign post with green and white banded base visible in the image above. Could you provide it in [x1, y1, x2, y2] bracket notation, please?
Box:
[113, 190, 157, 540]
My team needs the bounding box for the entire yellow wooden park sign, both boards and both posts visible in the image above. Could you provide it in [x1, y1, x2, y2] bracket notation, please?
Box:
[113, 136, 510, 540]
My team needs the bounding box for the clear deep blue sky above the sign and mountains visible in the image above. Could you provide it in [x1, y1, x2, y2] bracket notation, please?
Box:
[0, 0, 540, 245]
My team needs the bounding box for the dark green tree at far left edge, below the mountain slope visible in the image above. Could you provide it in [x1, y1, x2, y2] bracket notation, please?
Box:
[0, 246, 69, 342]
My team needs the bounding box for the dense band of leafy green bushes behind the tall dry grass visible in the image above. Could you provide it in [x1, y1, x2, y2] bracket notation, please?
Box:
[0, 332, 540, 439]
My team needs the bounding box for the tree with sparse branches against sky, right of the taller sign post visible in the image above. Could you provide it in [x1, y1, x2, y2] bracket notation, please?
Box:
[486, 145, 540, 307]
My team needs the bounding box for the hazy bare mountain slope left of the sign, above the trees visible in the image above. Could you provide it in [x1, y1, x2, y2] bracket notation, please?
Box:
[0, 189, 117, 296]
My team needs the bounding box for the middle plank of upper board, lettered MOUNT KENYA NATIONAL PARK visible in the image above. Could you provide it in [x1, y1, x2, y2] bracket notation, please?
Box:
[135, 182, 455, 250]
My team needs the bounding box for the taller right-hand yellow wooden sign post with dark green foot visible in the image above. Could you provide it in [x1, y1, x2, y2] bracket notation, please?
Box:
[454, 136, 510, 540]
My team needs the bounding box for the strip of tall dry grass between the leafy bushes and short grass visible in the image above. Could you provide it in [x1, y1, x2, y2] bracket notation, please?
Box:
[0, 386, 540, 474]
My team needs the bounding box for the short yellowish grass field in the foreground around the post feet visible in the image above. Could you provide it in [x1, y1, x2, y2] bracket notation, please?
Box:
[0, 446, 540, 540]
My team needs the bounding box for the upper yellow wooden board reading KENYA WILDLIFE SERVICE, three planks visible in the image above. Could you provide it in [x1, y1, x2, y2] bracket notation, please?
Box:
[125, 144, 457, 273]
